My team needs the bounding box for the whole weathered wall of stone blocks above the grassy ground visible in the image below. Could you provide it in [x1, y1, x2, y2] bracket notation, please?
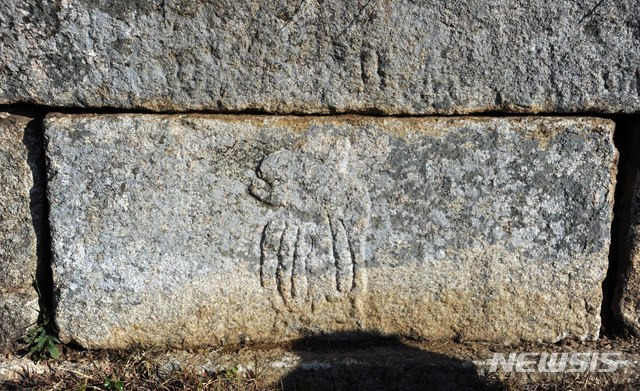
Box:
[0, 0, 640, 354]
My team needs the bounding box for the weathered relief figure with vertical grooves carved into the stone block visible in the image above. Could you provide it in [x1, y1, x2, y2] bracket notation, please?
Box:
[249, 139, 371, 309]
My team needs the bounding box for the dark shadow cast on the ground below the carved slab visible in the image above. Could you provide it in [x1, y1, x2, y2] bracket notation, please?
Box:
[274, 332, 504, 391]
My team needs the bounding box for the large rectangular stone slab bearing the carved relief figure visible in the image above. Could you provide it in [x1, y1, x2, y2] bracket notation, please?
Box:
[45, 115, 617, 348]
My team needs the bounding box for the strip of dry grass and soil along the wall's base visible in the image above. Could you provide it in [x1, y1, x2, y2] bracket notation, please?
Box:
[0, 337, 640, 390]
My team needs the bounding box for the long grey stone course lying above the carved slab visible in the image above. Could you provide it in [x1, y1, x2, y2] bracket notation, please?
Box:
[0, 0, 640, 114]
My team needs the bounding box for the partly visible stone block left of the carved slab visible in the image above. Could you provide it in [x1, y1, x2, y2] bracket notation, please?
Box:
[0, 113, 41, 348]
